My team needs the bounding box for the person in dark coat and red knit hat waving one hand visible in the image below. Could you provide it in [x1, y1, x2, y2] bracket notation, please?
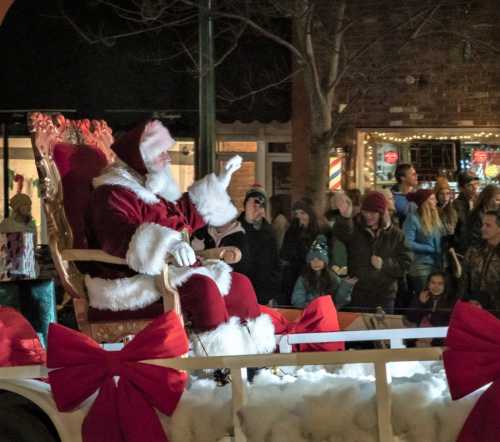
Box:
[333, 192, 412, 313]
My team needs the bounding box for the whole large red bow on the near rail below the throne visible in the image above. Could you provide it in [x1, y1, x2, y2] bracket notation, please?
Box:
[47, 312, 188, 442]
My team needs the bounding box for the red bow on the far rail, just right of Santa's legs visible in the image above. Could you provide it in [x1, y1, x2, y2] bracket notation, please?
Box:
[260, 296, 345, 351]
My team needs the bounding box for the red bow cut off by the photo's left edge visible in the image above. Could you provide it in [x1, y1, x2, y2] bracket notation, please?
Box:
[0, 307, 45, 367]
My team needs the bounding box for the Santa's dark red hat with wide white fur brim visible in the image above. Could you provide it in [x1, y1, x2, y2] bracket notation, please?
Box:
[111, 120, 175, 175]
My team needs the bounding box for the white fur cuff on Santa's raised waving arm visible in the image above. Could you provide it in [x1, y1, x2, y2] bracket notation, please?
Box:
[188, 173, 238, 227]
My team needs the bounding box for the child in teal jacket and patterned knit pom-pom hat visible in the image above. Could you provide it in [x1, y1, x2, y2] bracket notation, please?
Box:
[292, 235, 357, 309]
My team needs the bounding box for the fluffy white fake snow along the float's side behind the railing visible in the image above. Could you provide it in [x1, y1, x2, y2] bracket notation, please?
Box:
[163, 362, 482, 442]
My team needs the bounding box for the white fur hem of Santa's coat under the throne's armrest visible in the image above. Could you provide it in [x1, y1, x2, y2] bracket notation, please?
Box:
[85, 275, 161, 312]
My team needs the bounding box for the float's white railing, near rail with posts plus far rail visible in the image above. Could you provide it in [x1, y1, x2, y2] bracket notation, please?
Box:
[0, 327, 447, 442]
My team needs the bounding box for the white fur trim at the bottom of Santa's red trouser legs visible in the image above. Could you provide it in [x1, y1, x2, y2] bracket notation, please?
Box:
[191, 315, 276, 356]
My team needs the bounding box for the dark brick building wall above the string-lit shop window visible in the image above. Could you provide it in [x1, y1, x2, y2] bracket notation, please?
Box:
[292, 0, 500, 197]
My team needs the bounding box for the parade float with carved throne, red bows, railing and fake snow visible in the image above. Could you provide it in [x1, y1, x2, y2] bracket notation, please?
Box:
[0, 114, 492, 442]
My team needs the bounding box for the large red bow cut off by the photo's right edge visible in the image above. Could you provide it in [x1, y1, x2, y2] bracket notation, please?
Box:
[443, 302, 500, 442]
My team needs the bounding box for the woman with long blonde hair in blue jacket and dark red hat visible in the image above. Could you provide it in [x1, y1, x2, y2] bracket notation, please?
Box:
[403, 189, 445, 294]
